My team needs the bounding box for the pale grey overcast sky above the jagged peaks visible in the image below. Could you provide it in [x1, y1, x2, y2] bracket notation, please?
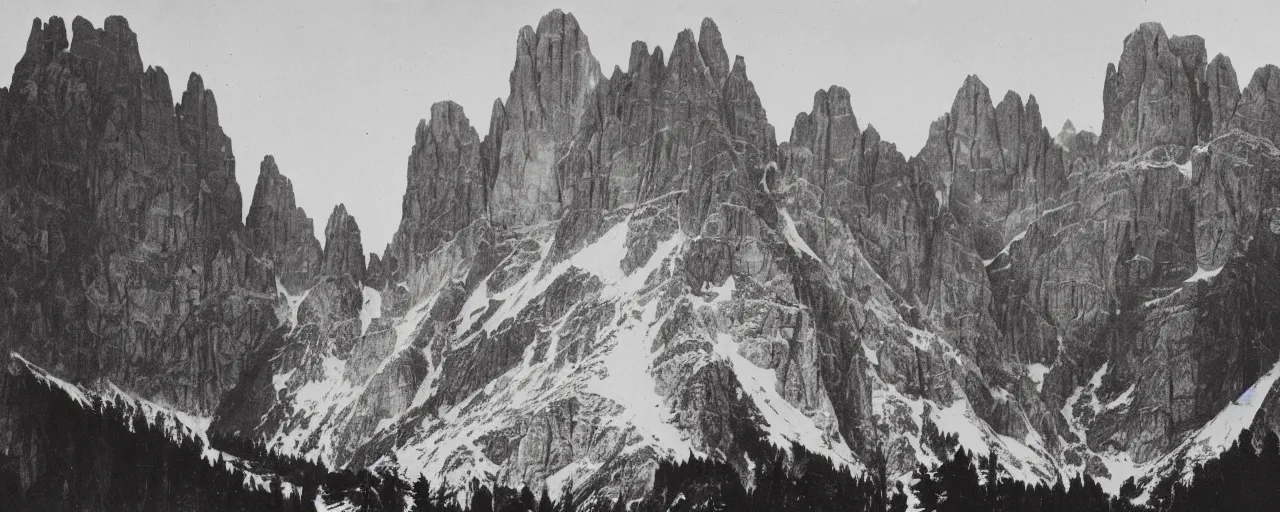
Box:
[0, 0, 1280, 252]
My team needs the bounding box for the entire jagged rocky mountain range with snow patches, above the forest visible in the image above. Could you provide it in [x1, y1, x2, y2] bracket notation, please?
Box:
[0, 10, 1280, 506]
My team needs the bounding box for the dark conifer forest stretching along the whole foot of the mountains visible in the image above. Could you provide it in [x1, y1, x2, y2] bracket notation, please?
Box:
[0, 360, 1280, 512]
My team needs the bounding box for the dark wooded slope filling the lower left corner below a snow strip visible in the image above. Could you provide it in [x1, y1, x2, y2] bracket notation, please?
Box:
[0, 371, 316, 512]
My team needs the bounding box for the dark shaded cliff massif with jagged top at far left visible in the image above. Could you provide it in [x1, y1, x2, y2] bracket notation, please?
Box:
[0, 17, 275, 412]
